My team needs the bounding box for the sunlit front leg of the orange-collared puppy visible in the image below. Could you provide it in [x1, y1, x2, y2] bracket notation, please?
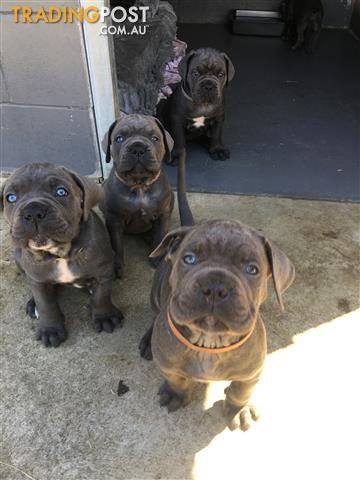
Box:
[224, 378, 258, 430]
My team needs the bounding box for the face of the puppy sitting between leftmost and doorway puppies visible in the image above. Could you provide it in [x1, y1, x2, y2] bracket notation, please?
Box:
[111, 115, 167, 186]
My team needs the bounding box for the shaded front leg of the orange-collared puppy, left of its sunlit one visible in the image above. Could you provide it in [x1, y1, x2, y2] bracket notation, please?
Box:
[158, 372, 194, 413]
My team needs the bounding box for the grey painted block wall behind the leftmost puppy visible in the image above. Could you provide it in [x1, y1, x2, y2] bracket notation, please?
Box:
[0, 0, 100, 174]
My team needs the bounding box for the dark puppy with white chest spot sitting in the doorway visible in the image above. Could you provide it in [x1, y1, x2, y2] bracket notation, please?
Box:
[157, 48, 235, 165]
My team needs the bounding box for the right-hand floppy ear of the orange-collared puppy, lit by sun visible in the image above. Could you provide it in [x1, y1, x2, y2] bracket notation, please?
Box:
[265, 239, 295, 310]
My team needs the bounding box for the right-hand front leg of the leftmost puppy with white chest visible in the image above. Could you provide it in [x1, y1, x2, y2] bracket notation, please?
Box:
[92, 279, 124, 333]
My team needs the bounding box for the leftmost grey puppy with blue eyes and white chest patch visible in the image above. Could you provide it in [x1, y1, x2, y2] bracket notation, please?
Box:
[3, 163, 123, 347]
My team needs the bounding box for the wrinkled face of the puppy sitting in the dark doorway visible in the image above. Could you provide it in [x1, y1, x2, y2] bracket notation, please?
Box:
[186, 51, 227, 104]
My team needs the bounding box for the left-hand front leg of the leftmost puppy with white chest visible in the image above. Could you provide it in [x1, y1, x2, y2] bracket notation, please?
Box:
[28, 279, 67, 347]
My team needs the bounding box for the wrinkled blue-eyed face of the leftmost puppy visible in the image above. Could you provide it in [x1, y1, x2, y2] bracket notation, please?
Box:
[3, 164, 83, 253]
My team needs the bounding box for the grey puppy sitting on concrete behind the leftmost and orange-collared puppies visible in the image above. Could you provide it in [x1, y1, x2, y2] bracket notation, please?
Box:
[100, 114, 174, 278]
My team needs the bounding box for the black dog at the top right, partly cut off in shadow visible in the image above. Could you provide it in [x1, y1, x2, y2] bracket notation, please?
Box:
[281, 0, 324, 53]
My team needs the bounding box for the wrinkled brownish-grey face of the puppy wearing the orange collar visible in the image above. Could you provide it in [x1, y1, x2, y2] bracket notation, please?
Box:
[169, 221, 270, 336]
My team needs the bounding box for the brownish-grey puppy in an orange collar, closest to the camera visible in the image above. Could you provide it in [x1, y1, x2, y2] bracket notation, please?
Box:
[140, 220, 294, 430]
